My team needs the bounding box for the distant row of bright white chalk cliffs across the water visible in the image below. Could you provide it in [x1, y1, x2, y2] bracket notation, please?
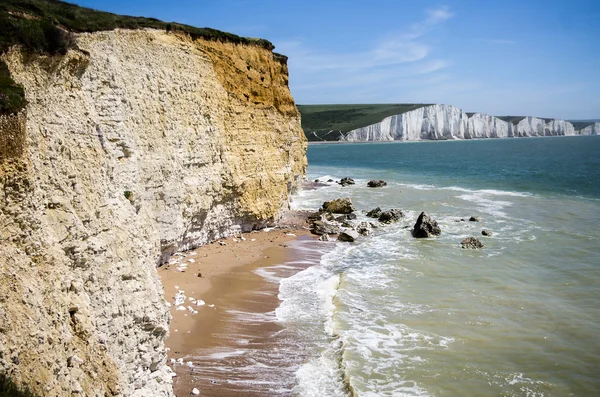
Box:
[340, 105, 599, 142]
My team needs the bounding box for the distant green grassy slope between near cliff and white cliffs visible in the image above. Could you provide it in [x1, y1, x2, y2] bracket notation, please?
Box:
[298, 103, 427, 141]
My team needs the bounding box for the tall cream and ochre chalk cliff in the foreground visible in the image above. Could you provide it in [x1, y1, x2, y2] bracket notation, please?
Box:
[0, 30, 306, 396]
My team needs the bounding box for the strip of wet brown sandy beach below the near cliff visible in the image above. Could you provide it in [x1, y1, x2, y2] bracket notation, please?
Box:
[158, 212, 314, 397]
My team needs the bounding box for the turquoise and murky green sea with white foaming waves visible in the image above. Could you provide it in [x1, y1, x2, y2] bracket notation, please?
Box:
[276, 136, 600, 396]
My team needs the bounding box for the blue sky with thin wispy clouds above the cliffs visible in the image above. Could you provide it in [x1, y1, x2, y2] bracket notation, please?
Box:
[72, 0, 600, 120]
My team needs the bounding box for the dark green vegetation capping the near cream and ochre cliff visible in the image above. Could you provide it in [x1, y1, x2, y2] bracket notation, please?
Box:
[0, 0, 276, 114]
